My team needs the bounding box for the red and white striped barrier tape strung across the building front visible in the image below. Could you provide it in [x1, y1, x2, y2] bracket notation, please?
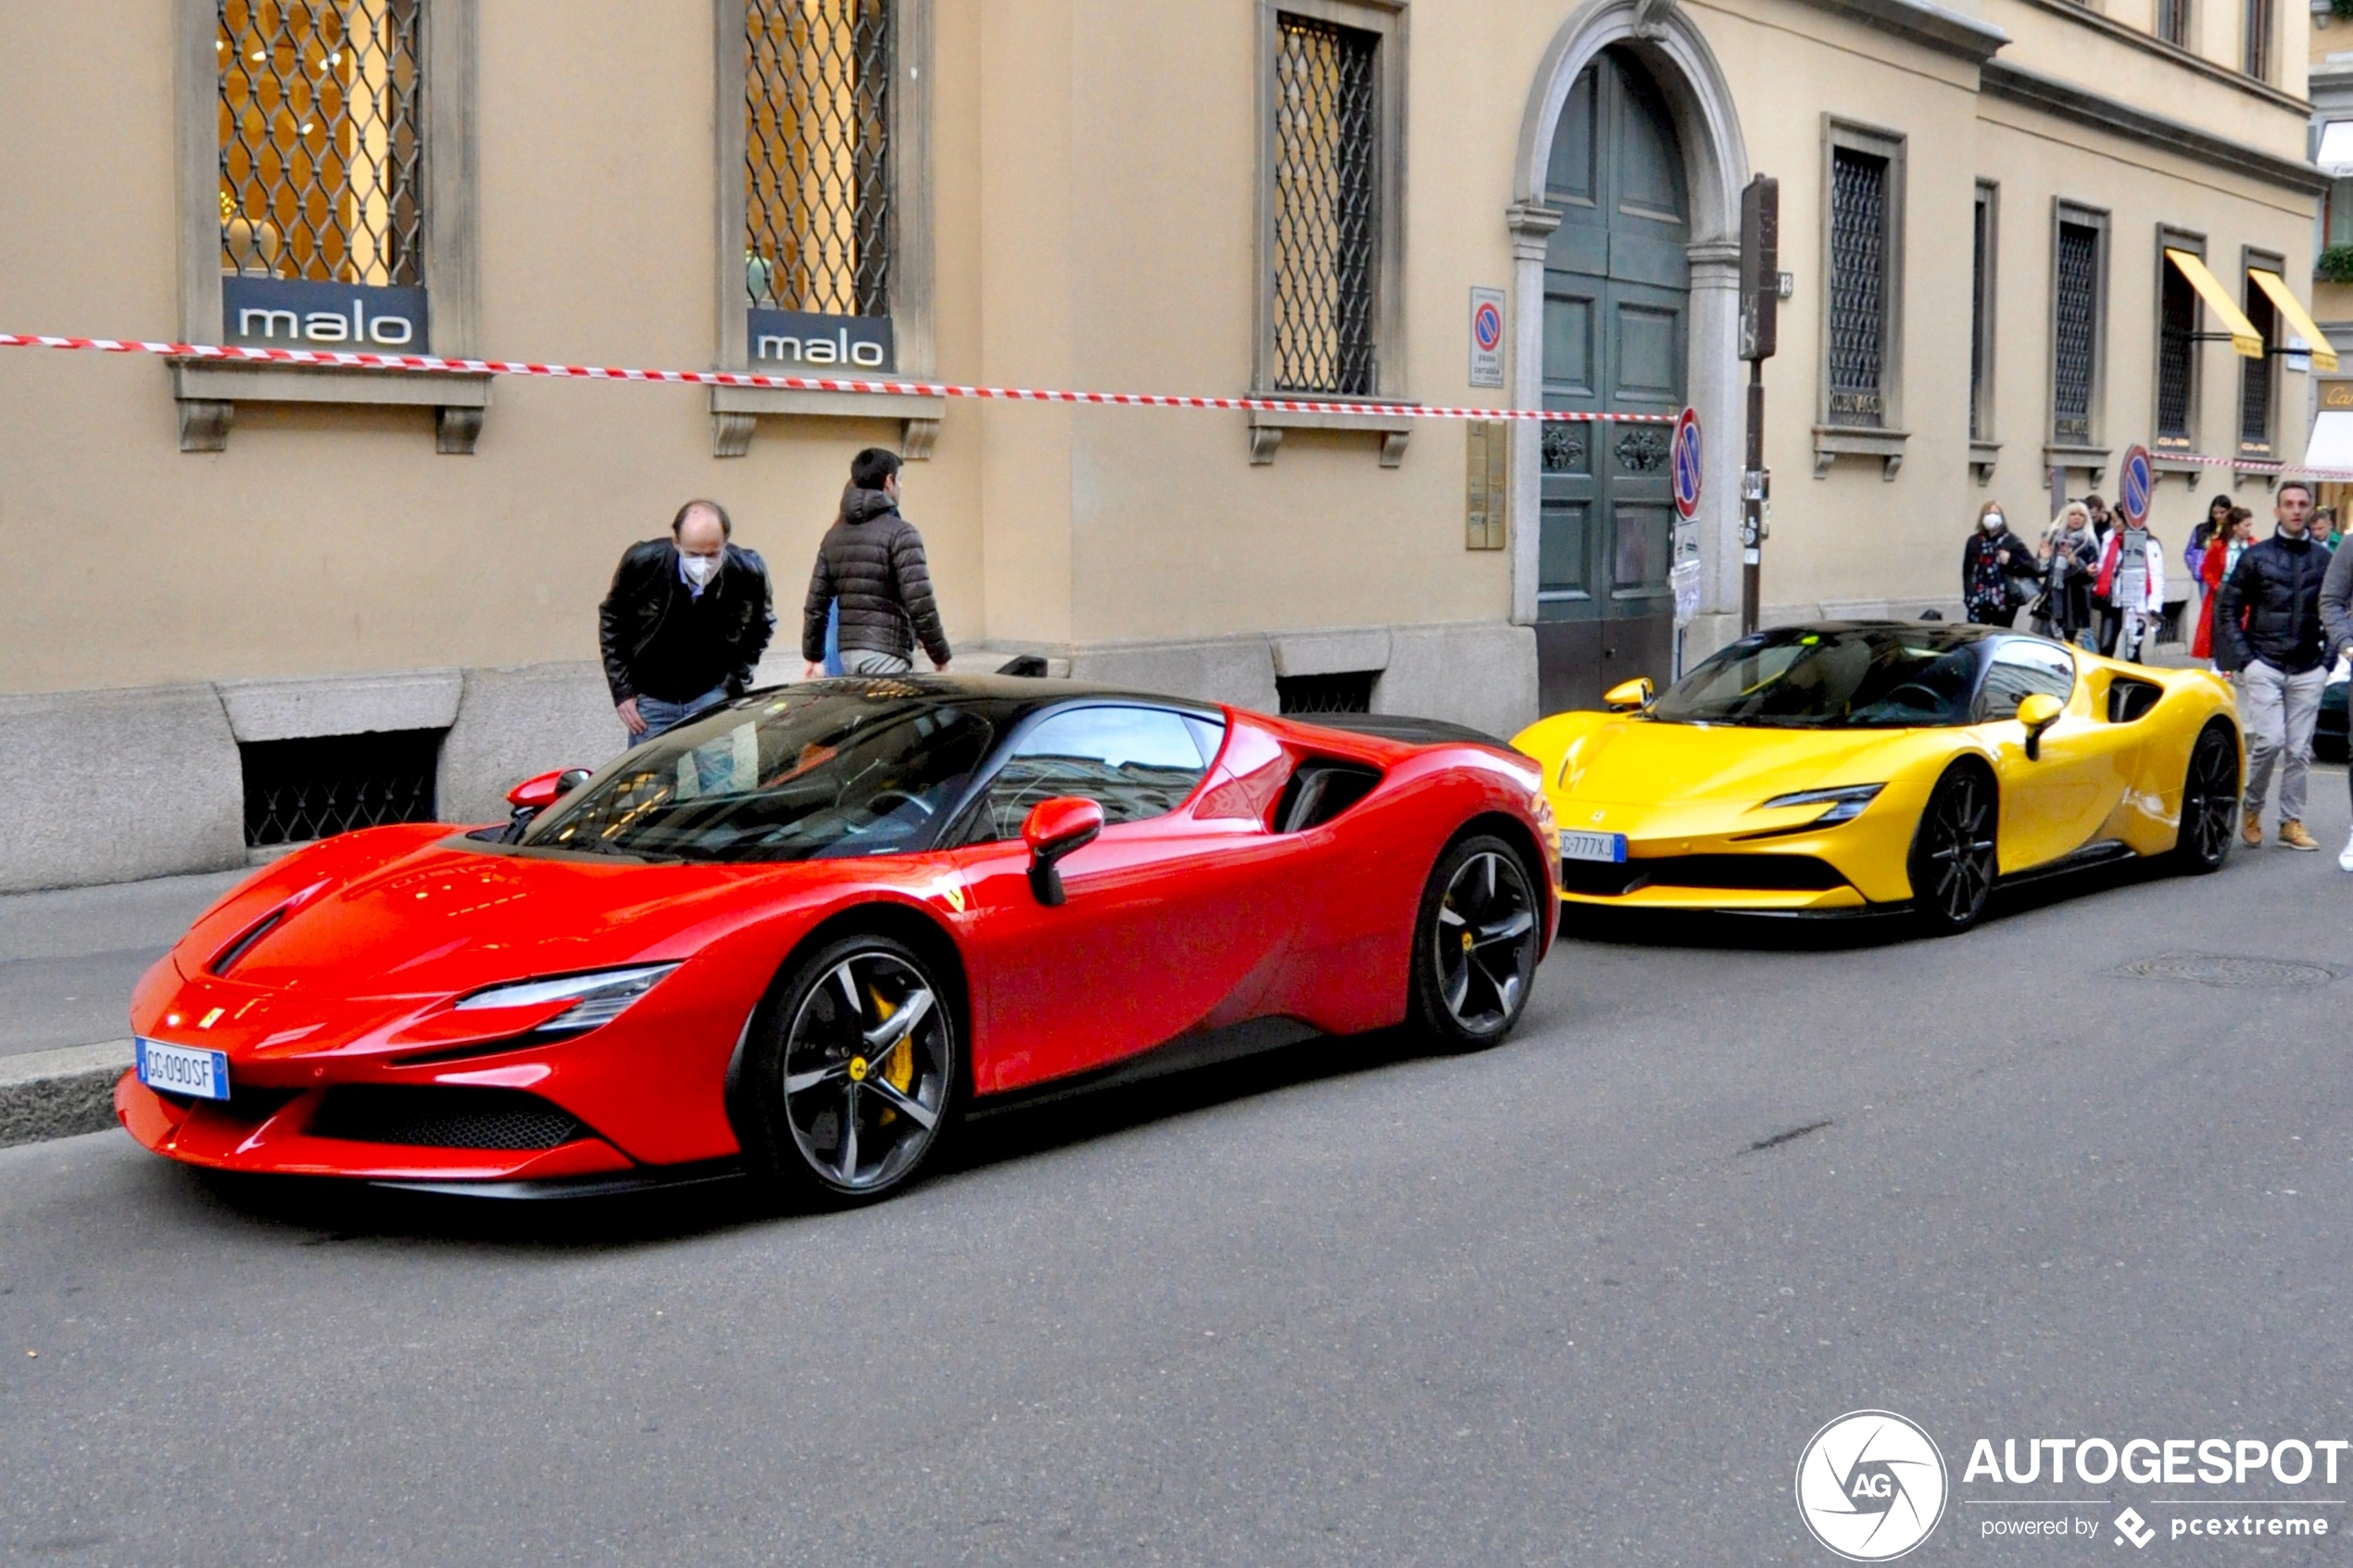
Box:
[0, 332, 1675, 425]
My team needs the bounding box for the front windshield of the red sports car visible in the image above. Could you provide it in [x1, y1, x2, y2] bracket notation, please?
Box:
[522, 686, 995, 860]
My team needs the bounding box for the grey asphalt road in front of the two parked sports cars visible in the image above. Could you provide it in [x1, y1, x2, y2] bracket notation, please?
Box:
[0, 771, 2353, 1568]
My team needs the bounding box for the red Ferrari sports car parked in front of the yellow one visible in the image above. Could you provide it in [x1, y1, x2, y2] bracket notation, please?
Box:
[115, 677, 1557, 1201]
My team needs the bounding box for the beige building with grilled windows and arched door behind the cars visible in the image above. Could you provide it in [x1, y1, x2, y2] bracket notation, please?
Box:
[0, 0, 2348, 886]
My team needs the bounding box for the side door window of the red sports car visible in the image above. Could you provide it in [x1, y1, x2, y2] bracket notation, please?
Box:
[986, 708, 1224, 839]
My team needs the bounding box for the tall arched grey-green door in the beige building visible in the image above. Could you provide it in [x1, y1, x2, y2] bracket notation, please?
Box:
[1537, 47, 1692, 712]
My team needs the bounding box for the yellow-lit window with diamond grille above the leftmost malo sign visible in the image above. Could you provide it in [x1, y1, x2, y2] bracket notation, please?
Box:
[214, 0, 426, 284]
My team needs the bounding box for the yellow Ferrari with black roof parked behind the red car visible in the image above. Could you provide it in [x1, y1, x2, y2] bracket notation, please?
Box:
[1513, 621, 2240, 931]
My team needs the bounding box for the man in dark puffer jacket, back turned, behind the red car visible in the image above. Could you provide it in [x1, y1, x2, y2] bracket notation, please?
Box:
[800, 446, 949, 680]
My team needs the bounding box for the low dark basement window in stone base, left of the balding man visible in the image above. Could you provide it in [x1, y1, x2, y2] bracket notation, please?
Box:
[238, 729, 447, 847]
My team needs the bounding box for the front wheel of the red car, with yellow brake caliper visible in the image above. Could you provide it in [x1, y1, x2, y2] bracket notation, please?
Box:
[734, 934, 964, 1206]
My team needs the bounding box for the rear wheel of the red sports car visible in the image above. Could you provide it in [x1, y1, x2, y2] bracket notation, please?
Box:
[1412, 834, 1551, 1051]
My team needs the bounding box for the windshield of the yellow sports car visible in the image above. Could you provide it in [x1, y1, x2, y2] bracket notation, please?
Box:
[1652, 625, 1977, 729]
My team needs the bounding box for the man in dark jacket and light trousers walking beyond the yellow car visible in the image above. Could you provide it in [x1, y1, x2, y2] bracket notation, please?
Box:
[2214, 480, 2334, 848]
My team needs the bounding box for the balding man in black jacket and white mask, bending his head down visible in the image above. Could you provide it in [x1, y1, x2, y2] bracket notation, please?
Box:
[598, 501, 776, 746]
